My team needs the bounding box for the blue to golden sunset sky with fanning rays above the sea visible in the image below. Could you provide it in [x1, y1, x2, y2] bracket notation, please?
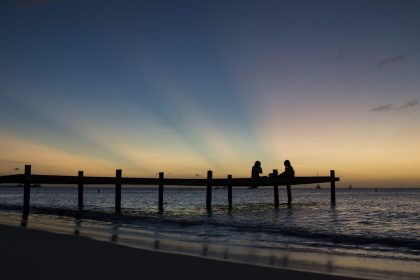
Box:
[0, 0, 420, 187]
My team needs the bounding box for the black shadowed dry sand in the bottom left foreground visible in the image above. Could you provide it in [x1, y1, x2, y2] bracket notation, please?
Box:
[0, 225, 360, 280]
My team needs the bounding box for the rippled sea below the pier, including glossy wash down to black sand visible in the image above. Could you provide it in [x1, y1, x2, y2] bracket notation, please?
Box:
[0, 186, 420, 279]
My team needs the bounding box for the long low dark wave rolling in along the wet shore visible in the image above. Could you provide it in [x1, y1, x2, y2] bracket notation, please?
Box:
[0, 205, 420, 254]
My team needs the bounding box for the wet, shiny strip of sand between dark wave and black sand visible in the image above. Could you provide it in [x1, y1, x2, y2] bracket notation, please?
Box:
[0, 212, 420, 280]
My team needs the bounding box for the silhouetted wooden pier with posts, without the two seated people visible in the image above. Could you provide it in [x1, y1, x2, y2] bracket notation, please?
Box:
[0, 165, 340, 215]
